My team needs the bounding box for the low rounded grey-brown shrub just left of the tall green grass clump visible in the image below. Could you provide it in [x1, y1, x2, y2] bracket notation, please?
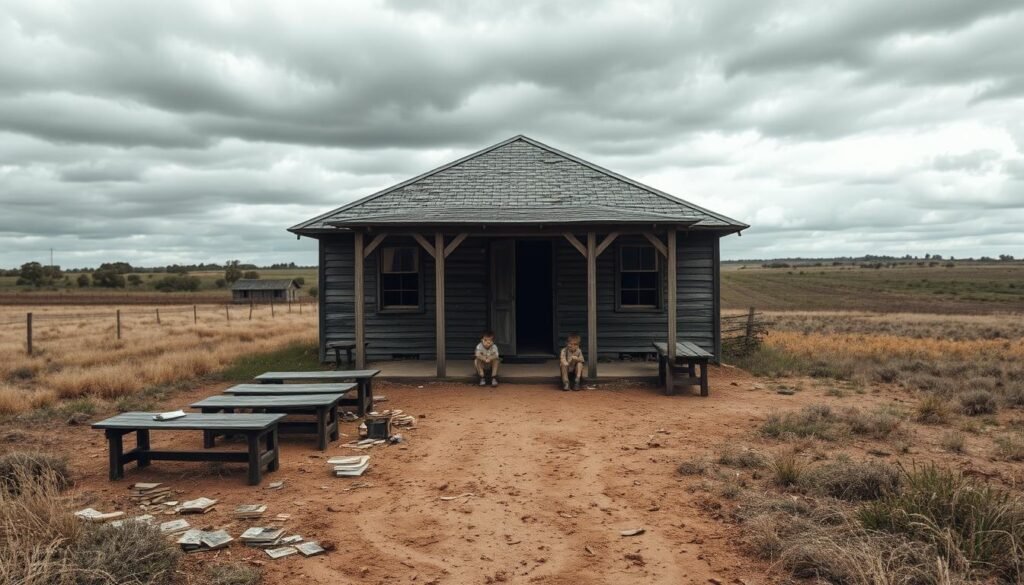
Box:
[800, 459, 900, 501]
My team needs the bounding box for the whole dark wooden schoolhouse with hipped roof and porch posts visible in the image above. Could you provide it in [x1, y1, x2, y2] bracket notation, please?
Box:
[289, 135, 748, 378]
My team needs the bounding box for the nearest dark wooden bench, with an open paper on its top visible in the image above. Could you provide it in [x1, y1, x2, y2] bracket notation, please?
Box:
[92, 412, 285, 486]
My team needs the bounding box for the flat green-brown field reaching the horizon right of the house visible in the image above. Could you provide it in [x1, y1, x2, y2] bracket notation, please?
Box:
[722, 262, 1024, 315]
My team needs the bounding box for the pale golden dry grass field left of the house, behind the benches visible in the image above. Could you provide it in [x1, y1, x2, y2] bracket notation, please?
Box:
[0, 305, 316, 416]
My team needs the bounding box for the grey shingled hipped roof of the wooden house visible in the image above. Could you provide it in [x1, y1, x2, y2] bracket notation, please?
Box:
[289, 135, 748, 236]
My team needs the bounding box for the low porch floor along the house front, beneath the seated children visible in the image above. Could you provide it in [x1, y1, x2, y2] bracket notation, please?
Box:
[367, 360, 657, 384]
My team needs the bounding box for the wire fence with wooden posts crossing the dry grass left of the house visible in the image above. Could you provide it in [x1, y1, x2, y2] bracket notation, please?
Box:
[0, 301, 317, 356]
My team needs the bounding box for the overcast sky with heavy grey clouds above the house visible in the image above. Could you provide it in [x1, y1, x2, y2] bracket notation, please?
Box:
[0, 0, 1024, 266]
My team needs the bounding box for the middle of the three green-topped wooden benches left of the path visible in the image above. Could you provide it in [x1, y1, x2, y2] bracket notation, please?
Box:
[189, 393, 344, 451]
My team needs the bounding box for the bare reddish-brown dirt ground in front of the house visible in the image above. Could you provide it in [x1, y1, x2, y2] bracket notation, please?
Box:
[0, 368, 958, 585]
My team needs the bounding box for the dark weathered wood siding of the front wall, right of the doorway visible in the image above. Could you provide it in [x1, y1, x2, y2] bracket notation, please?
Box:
[555, 232, 718, 358]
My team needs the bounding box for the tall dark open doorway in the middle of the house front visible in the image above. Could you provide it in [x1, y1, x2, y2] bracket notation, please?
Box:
[515, 240, 554, 356]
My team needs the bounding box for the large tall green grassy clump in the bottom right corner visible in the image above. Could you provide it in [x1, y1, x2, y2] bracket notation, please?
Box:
[858, 465, 1024, 581]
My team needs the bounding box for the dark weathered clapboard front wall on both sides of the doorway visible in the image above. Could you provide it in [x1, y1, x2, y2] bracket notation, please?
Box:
[319, 232, 719, 360]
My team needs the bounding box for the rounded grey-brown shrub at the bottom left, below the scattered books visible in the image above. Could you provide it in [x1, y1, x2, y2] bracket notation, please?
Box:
[74, 523, 181, 585]
